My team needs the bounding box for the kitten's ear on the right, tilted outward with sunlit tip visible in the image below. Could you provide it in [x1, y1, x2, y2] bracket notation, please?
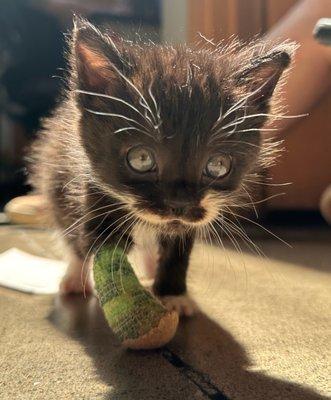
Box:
[236, 45, 294, 107]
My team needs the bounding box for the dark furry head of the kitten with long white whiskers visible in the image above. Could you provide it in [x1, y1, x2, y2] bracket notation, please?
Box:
[72, 21, 293, 234]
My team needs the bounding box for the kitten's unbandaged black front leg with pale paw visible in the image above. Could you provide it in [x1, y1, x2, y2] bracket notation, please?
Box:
[153, 235, 197, 316]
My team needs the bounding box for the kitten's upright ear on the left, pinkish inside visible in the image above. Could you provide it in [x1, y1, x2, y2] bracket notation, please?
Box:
[72, 18, 127, 92]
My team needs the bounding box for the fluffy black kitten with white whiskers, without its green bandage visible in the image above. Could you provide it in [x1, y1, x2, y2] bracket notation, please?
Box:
[31, 20, 293, 315]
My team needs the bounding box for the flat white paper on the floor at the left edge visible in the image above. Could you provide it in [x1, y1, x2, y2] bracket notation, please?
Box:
[0, 248, 66, 294]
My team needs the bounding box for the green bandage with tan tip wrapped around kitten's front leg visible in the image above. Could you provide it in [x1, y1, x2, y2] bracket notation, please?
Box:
[93, 246, 178, 349]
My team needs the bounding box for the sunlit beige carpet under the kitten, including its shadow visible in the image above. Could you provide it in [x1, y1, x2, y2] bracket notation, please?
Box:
[0, 227, 331, 400]
